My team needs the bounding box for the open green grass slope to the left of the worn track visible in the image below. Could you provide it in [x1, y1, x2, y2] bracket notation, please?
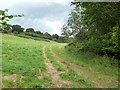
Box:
[2, 35, 51, 87]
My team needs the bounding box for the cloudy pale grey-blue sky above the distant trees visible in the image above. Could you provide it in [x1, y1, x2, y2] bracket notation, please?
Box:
[0, 0, 72, 35]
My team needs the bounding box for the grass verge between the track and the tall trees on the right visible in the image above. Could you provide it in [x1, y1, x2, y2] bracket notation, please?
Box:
[52, 44, 118, 88]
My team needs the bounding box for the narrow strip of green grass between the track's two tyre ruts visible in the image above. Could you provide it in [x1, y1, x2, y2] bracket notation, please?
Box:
[45, 46, 93, 88]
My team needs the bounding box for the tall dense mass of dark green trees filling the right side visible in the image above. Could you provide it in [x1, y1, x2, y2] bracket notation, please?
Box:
[63, 2, 120, 59]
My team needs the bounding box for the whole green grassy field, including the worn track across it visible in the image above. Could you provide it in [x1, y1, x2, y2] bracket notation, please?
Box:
[1, 34, 118, 88]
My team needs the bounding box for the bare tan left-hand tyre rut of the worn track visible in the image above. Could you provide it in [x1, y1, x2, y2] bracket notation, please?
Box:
[43, 46, 70, 87]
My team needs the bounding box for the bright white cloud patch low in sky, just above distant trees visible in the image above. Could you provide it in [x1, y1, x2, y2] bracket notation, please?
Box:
[45, 21, 63, 35]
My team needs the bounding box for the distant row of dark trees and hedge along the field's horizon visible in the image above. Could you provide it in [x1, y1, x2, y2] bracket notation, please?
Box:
[1, 24, 69, 43]
